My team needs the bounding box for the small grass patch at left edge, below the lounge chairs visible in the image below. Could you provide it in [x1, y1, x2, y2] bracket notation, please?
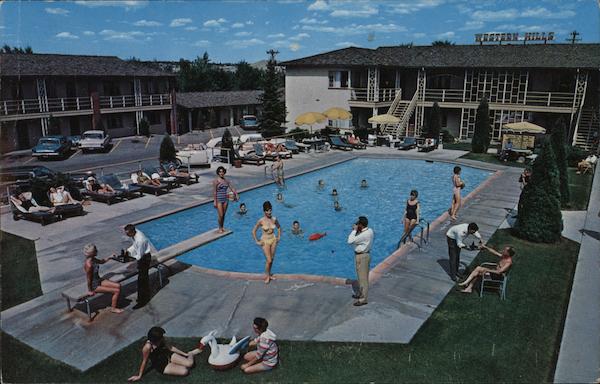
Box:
[0, 231, 42, 310]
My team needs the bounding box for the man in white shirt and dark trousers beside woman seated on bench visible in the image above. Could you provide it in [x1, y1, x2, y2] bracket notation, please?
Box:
[125, 224, 153, 309]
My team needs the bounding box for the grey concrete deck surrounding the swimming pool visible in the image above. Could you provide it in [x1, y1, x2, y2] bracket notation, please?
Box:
[1, 147, 520, 371]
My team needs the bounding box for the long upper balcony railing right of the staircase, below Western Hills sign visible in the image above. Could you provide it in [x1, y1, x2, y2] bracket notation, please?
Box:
[425, 89, 573, 107]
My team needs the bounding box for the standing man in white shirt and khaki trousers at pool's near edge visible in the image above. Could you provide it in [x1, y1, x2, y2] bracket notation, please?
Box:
[348, 216, 373, 307]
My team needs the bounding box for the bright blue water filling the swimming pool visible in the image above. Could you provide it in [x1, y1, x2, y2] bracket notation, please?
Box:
[139, 159, 491, 278]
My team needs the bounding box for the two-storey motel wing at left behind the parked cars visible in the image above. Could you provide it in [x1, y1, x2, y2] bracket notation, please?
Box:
[0, 53, 176, 152]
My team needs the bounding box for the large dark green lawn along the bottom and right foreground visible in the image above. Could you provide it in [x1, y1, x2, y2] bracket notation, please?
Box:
[2, 230, 579, 383]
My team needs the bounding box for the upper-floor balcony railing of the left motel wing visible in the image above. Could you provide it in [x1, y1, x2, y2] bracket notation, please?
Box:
[0, 93, 171, 116]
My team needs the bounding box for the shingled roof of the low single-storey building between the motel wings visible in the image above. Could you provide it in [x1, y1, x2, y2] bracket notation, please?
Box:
[177, 91, 263, 108]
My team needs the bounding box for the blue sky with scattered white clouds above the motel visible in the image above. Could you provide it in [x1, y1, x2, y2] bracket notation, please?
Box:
[0, 0, 600, 63]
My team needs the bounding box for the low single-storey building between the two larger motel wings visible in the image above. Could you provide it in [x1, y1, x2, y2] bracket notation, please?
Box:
[177, 90, 263, 133]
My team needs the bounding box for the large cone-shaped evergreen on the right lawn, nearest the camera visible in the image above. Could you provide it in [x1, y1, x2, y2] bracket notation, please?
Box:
[515, 139, 563, 243]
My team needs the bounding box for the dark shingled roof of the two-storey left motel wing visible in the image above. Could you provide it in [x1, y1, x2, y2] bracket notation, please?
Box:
[0, 53, 174, 77]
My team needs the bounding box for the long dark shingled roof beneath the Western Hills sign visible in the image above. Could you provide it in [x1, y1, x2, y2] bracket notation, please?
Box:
[281, 44, 600, 69]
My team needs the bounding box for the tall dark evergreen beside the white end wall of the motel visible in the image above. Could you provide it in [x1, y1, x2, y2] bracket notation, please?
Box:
[260, 50, 286, 138]
